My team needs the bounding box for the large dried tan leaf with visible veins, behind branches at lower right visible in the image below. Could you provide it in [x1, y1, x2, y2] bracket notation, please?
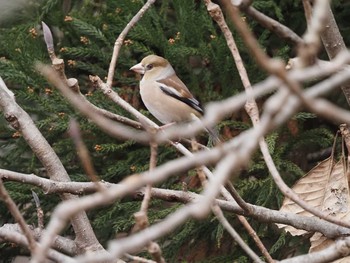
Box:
[278, 151, 350, 263]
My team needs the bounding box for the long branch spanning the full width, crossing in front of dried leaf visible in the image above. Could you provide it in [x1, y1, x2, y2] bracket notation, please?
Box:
[0, 169, 350, 238]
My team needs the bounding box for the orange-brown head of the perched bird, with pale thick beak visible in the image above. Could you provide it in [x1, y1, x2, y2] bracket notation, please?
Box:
[130, 55, 175, 79]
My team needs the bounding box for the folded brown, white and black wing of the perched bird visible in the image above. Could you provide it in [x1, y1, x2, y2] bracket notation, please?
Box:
[157, 75, 204, 114]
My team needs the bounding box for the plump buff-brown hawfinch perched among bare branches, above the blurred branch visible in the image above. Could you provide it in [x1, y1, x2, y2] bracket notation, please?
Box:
[130, 55, 203, 124]
